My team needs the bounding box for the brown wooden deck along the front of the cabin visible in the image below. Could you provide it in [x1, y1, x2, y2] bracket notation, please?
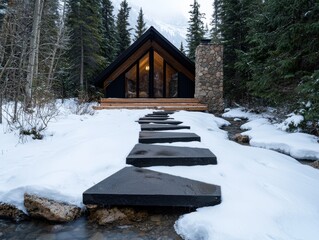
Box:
[94, 98, 207, 111]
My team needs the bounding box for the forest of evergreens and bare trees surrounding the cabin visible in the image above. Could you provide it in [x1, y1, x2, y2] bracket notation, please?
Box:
[0, 0, 319, 135]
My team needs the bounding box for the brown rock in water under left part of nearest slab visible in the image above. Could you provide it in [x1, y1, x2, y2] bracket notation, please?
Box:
[89, 207, 127, 225]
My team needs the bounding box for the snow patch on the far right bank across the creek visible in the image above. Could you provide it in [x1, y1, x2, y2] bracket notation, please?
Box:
[223, 108, 319, 160]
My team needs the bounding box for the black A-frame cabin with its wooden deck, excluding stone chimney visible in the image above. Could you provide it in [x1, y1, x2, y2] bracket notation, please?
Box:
[95, 27, 225, 111]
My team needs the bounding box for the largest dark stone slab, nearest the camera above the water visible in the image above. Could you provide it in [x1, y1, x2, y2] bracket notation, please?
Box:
[83, 167, 221, 208]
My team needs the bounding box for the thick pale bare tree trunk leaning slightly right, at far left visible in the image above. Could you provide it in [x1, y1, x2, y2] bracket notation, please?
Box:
[25, 0, 44, 108]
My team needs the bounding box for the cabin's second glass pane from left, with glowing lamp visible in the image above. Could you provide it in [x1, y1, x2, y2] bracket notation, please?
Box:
[139, 54, 150, 98]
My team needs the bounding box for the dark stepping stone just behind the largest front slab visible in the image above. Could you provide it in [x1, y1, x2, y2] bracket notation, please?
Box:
[126, 144, 217, 167]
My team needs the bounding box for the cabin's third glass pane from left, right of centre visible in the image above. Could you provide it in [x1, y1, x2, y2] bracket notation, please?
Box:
[153, 52, 164, 98]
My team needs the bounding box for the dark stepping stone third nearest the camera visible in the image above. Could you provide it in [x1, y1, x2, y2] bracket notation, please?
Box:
[138, 131, 200, 143]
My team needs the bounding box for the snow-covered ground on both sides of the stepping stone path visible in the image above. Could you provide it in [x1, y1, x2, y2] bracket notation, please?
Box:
[0, 101, 319, 240]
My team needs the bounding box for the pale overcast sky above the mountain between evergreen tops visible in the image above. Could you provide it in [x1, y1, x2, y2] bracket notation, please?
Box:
[127, 0, 213, 26]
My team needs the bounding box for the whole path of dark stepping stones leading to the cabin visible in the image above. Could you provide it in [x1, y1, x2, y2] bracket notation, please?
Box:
[83, 111, 221, 208]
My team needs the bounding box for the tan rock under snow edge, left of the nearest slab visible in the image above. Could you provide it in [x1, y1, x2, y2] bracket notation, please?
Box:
[24, 193, 81, 222]
